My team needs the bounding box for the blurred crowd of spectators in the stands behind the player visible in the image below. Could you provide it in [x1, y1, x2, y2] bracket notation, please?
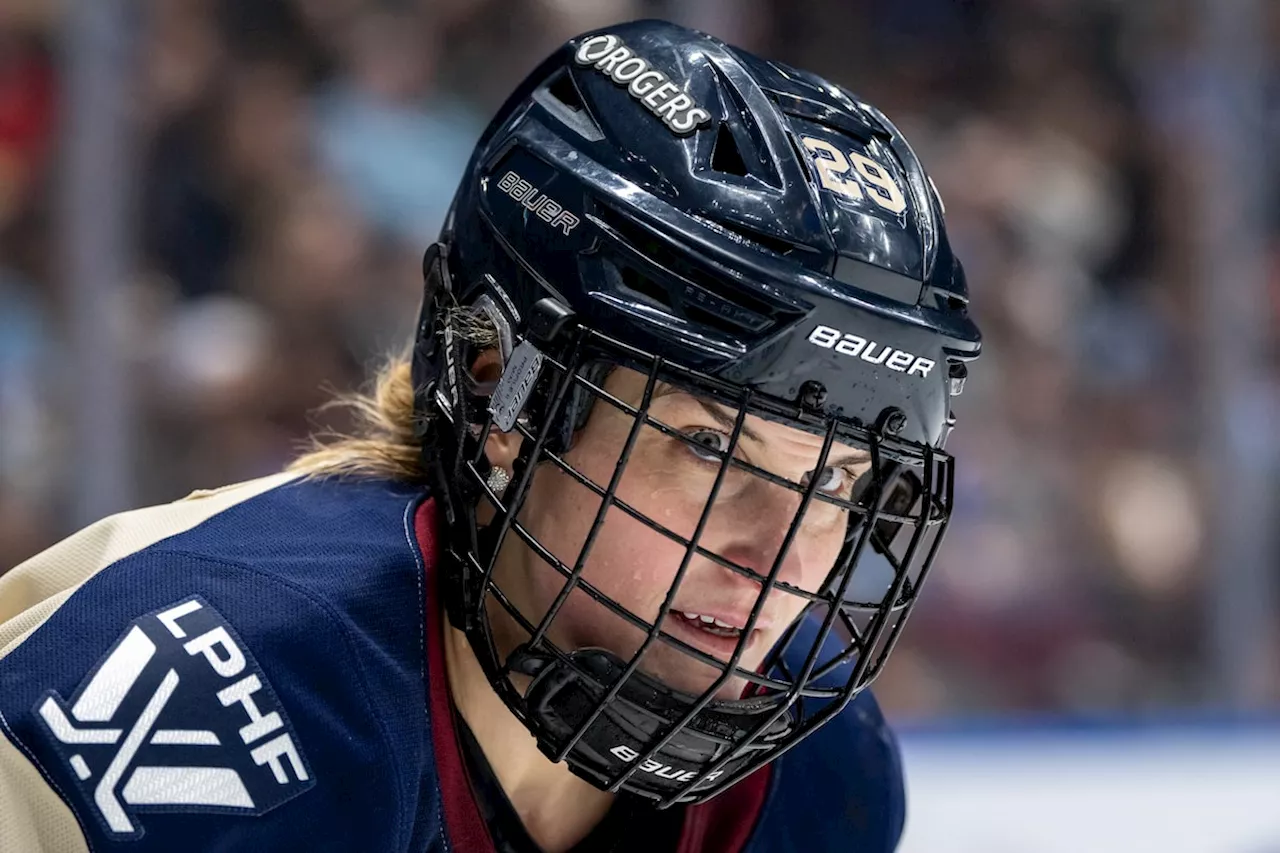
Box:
[0, 0, 1280, 719]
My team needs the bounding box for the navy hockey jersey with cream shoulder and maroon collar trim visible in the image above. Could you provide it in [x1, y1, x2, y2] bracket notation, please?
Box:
[0, 475, 904, 853]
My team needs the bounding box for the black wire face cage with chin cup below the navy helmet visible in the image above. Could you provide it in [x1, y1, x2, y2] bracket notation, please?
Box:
[426, 273, 954, 807]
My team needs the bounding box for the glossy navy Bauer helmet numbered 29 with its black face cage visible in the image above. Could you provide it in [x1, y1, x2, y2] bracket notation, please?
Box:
[413, 20, 980, 804]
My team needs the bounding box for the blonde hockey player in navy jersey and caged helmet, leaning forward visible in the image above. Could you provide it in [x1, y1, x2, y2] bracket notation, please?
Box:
[0, 22, 979, 853]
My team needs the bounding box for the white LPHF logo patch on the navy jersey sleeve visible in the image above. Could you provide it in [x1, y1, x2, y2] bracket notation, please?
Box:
[36, 597, 315, 839]
